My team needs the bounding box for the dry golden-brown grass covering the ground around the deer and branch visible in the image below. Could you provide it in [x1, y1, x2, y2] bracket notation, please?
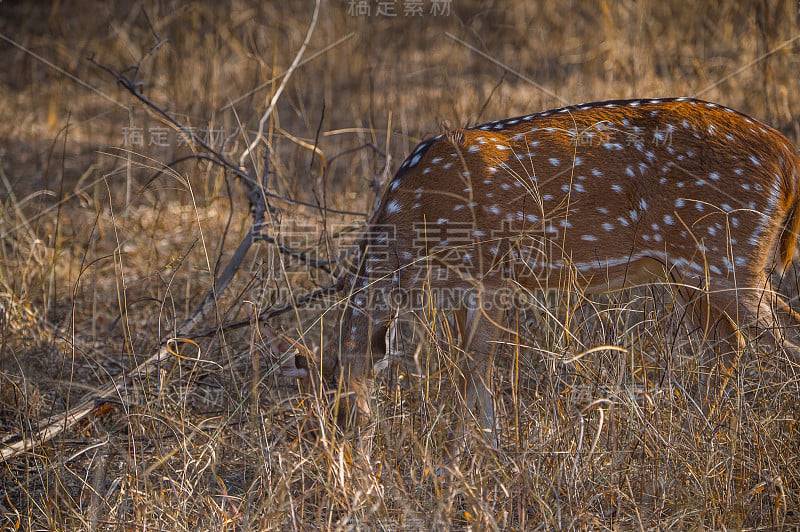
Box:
[0, 0, 800, 530]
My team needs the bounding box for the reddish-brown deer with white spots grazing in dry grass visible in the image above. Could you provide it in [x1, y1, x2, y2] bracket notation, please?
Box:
[282, 98, 800, 434]
